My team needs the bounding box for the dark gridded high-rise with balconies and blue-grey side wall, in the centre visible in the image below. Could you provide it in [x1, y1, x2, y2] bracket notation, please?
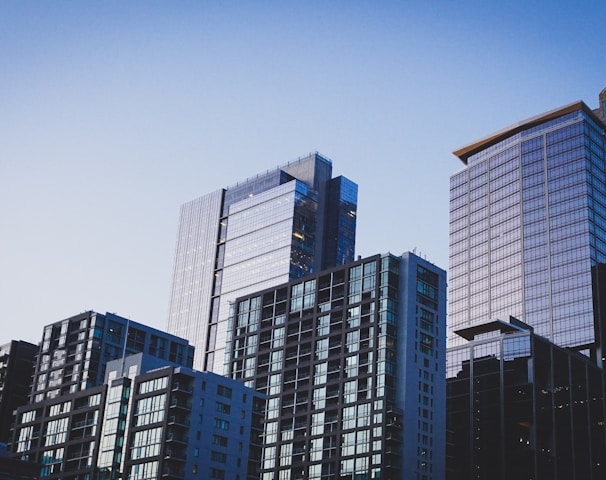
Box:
[228, 253, 446, 480]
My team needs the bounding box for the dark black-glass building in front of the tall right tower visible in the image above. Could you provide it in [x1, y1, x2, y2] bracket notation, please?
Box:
[446, 318, 606, 480]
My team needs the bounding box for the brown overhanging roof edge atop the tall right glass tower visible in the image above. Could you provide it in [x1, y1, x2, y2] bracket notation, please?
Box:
[452, 100, 604, 165]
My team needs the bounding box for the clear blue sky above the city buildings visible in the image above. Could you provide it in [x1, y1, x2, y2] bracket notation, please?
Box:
[0, 0, 606, 343]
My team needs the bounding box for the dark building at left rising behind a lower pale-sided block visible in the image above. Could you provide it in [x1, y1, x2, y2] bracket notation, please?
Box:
[30, 311, 194, 402]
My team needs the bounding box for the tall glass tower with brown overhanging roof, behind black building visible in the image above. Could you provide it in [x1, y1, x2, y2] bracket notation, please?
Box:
[448, 97, 606, 366]
